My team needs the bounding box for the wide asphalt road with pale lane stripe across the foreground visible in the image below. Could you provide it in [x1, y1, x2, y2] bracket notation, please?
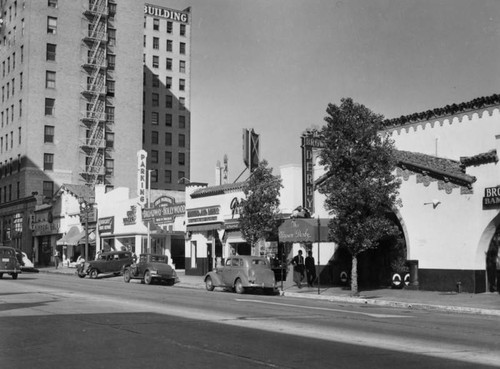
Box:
[0, 274, 500, 369]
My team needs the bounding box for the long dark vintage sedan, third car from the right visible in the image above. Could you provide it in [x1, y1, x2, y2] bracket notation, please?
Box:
[76, 251, 134, 278]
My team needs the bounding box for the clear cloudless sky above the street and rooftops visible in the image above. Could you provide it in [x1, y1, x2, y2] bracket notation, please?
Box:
[165, 0, 500, 185]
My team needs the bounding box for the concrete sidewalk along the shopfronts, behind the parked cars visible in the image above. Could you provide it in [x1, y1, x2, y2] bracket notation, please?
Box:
[35, 267, 500, 316]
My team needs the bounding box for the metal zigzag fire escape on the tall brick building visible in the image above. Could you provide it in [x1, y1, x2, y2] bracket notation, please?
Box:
[80, 0, 108, 186]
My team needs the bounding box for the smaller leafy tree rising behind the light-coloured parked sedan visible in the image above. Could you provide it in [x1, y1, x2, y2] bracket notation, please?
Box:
[239, 160, 283, 254]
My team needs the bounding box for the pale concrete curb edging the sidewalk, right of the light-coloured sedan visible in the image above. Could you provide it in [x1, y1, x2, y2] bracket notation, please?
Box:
[283, 292, 500, 316]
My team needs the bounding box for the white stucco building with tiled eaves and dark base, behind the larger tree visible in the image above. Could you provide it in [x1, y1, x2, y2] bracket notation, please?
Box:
[312, 95, 500, 293]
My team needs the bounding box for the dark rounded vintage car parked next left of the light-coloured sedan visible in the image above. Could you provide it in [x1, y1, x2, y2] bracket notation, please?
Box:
[123, 254, 179, 286]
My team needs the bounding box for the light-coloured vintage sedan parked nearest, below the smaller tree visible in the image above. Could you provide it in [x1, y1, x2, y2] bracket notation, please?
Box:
[204, 255, 277, 294]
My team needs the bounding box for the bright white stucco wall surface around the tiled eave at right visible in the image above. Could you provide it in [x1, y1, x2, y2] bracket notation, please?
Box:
[391, 108, 500, 269]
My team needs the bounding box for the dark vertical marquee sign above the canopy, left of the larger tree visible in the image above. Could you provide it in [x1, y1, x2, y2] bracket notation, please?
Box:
[300, 129, 325, 213]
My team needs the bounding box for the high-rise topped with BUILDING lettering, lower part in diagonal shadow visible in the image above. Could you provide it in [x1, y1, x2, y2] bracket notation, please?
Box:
[143, 4, 191, 191]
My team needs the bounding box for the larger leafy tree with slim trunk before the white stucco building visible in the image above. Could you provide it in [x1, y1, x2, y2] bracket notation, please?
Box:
[320, 98, 400, 294]
